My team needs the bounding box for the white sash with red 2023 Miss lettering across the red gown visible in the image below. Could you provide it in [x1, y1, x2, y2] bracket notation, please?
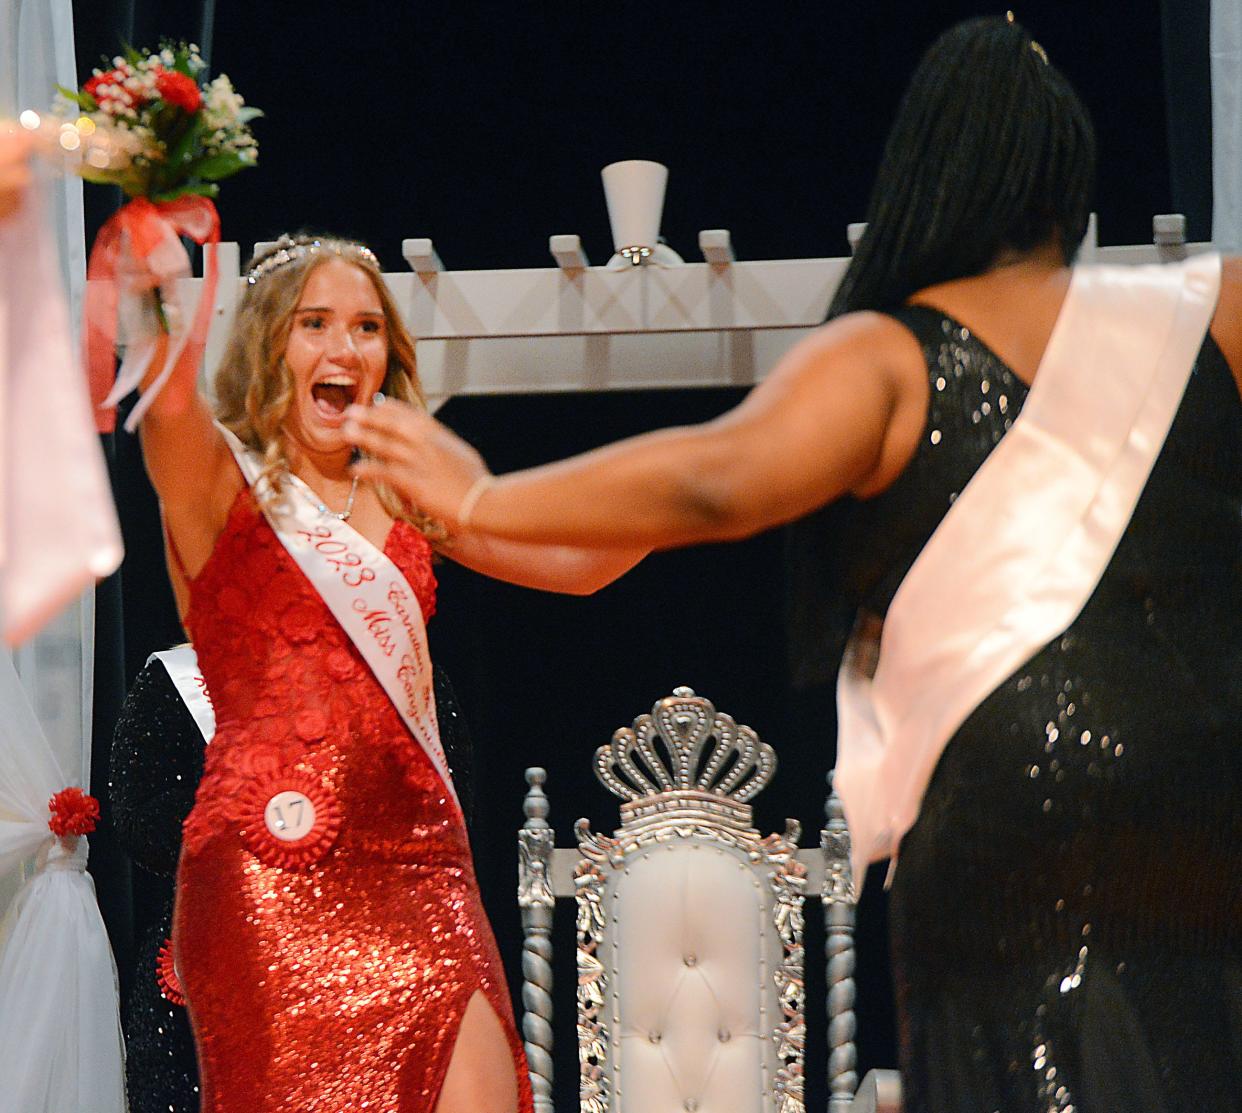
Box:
[217, 425, 461, 810]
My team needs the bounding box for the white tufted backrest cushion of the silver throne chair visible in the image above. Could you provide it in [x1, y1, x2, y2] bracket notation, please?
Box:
[600, 840, 779, 1113]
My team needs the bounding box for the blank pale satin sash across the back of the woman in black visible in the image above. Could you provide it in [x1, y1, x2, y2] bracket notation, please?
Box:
[835, 255, 1220, 889]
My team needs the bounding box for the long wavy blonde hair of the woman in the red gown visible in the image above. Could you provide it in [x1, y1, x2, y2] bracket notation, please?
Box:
[214, 234, 443, 540]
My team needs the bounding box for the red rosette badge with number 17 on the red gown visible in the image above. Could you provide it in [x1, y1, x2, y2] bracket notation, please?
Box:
[241, 770, 342, 870]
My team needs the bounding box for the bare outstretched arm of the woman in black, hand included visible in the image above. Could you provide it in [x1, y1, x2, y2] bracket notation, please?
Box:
[347, 313, 928, 549]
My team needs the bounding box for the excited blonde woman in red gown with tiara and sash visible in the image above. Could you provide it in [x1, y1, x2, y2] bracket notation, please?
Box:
[142, 237, 642, 1113]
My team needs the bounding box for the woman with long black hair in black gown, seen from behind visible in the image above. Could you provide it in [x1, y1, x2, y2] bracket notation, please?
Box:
[347, 19, 1242, 1113]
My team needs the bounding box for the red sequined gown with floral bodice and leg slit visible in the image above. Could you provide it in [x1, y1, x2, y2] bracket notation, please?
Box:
[174, 491, 530, 1113]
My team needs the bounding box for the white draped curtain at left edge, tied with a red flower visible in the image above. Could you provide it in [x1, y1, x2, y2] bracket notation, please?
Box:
[0, 0, 125, 1113]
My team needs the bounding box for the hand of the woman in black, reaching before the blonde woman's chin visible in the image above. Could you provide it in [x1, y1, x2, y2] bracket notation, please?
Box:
[343, 399, 491, 529]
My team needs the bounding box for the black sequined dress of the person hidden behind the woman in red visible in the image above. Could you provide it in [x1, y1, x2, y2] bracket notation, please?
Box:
[108, 661, 473, 1113]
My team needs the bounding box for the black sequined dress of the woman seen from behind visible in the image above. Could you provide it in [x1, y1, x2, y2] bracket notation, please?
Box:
[807, 307, 1242, 1113]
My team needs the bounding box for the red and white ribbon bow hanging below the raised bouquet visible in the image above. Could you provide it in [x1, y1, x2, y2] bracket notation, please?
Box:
[83, 195, 220, 432]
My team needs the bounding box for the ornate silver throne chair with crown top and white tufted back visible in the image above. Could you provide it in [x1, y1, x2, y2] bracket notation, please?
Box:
[518, 688, 899, 1113]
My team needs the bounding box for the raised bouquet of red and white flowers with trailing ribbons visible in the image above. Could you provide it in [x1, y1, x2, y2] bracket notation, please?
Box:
[56, 42, 262, 432]
